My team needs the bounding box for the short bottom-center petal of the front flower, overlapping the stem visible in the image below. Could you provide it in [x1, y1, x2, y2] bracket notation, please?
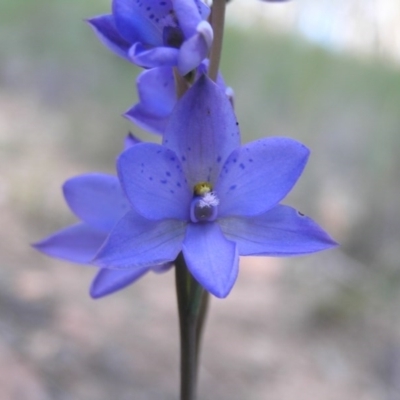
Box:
[182, 223, 239, 298]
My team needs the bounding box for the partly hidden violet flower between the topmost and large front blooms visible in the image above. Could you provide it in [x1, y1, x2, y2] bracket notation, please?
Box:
[124, 60, 233, 134]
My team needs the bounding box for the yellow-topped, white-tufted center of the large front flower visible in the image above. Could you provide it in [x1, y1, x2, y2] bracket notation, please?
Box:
[190, 182, 219, 222]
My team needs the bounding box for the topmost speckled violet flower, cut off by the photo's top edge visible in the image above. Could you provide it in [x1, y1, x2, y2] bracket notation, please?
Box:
[88, 0, 213, 75]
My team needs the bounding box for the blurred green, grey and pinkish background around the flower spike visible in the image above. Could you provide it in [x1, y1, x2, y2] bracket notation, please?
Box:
[0, 0, 400, 400]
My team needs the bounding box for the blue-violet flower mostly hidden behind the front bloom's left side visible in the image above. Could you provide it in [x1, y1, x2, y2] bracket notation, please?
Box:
[33, 135, 172, 298]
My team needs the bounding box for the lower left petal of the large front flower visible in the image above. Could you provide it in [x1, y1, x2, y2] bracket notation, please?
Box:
[93, 209, 186, 269]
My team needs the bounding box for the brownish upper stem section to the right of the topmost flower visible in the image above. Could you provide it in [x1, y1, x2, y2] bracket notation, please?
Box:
[208, 0, 226, 82]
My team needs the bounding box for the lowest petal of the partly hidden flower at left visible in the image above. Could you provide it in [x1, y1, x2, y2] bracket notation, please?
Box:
[90, 267, 150, 299]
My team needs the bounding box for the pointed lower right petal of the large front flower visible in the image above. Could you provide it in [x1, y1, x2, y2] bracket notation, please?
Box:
[218, 205, 337, 256]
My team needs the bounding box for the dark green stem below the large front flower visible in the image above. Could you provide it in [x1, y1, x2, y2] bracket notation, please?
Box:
[175, 253, 208, 400]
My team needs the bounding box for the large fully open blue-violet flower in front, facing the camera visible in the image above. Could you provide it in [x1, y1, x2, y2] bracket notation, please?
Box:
[94, 76, 336, 297]
